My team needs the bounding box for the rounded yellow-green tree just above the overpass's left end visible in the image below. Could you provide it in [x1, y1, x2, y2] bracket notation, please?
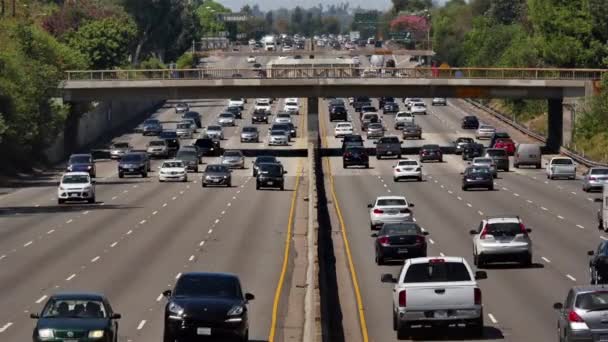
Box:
[69, 18, 137, 70]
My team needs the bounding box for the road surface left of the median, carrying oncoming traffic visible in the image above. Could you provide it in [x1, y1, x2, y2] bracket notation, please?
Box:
[0, 52, 306, 342]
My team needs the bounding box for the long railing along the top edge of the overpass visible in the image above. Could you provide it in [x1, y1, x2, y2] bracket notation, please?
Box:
[66, 66, 608, 81]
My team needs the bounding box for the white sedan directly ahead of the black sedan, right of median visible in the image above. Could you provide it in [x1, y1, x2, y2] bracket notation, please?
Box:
[367, 196, 414, 230]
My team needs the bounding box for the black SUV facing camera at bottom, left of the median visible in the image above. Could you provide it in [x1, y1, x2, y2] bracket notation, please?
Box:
[163, 272, 255, 342]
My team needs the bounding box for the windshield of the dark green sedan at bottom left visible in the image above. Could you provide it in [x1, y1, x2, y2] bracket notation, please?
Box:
[41, 299, 108, 318]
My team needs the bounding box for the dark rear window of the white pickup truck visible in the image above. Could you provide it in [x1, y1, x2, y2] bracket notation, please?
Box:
[403, 262, 471, 283]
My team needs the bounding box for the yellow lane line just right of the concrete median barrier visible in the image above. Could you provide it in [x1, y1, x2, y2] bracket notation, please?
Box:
[319, 106, 369, 342]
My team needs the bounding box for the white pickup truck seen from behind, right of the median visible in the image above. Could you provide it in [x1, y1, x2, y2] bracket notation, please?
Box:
[382, 257, 487, 339]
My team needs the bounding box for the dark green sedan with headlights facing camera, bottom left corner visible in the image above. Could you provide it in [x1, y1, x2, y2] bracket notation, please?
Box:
[30, 292, 121, 342]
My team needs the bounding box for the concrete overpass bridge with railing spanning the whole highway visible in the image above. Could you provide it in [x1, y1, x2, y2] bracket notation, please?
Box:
[59, 66, 608, 150]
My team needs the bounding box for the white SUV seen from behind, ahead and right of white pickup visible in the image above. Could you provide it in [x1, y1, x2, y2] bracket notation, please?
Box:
[469, 216, 532, 267]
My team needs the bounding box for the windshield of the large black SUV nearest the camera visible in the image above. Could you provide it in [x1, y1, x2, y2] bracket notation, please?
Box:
[174, 275, 242, 298]
